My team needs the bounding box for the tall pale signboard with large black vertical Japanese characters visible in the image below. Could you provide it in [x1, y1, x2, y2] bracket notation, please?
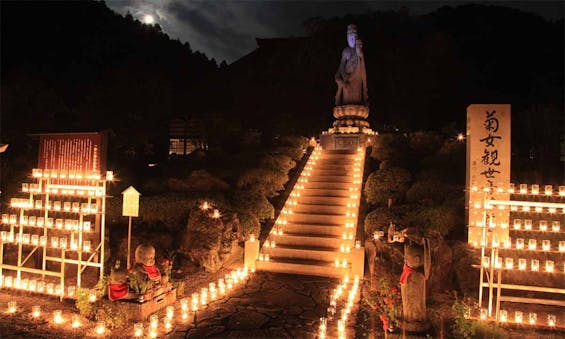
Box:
[465, 104, 510, 245]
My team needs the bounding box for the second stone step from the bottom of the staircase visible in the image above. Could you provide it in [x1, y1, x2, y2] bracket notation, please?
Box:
[261, 244, 340, 263]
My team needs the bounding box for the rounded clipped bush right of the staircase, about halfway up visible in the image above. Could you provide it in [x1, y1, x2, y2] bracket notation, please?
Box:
[365, 167, 411, 205]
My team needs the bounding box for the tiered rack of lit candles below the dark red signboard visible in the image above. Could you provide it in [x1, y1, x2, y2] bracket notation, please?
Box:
[0, 169, 113, 299]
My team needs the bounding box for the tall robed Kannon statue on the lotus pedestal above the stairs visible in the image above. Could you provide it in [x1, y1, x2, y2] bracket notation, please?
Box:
[335, 25, 369, 106]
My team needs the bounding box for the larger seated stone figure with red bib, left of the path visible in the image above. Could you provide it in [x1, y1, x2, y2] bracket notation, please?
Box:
[130, 244, 171, 301]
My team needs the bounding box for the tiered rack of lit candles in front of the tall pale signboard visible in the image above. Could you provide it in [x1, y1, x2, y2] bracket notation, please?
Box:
[471, 184, 565, 328]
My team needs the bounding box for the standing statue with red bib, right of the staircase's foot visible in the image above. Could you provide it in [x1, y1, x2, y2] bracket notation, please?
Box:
[388, 224, 431, 332]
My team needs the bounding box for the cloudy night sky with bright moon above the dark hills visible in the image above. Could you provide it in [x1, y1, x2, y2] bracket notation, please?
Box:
[106, 0, 564, 63]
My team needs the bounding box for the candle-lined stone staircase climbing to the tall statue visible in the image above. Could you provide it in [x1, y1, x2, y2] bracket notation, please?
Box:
[255, 148, 364, 278]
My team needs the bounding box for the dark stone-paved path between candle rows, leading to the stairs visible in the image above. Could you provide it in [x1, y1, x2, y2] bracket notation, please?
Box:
[174, 272, 338, 338]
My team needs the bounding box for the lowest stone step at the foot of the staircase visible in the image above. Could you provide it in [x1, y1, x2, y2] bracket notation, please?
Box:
[255, 258, 349, 278]
